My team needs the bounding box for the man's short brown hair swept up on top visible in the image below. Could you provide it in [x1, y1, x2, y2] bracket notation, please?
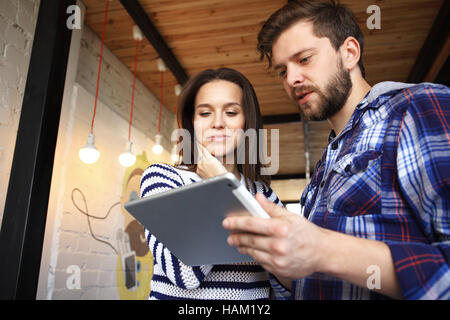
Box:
[258, 0, 365, 77]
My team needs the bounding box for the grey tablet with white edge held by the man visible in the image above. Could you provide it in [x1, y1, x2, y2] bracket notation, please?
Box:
[125, 173, 269, 266]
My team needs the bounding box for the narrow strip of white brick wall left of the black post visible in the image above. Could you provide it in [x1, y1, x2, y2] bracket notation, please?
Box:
[0, 0, 39, 223]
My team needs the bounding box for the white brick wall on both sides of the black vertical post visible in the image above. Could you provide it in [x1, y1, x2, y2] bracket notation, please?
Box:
[0, 0, 176, 299]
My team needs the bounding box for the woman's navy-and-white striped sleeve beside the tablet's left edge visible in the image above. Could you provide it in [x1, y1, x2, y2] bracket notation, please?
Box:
[140, 164, 213, 289]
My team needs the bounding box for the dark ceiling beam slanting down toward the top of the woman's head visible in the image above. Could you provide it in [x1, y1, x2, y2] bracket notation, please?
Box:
[120, 0, 189, 85]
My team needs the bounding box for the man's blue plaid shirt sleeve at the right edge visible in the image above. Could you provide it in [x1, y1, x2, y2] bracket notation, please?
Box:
[386, 85, 450, 300]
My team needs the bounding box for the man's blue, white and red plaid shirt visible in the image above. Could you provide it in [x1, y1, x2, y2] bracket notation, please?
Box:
[271, 82, 450, 299]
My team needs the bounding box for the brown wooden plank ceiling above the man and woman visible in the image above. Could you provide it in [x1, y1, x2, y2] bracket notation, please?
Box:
[83, 0, 443, 189]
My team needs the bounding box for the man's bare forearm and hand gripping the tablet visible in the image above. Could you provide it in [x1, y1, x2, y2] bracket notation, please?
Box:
[223, 194, 402, 299]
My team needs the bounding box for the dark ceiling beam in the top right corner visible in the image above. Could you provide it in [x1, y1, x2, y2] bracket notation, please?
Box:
[407, 1, 450, 83]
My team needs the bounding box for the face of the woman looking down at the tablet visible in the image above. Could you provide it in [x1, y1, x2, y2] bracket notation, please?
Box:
[193, 80, 245, 157]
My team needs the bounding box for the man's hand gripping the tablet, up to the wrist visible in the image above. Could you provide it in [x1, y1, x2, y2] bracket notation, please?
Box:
[223, 194, 325, 279]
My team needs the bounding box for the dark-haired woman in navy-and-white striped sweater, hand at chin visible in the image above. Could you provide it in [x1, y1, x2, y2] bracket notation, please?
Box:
[141, 68, 281, 300]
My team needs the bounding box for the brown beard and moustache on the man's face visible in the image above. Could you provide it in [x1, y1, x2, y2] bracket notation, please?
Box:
[292, 60, 352, 121]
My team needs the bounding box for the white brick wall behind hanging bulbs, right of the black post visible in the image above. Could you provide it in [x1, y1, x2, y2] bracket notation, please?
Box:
[38, 1, 176, 299]
